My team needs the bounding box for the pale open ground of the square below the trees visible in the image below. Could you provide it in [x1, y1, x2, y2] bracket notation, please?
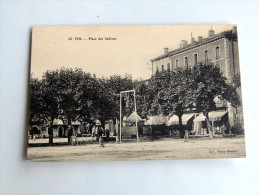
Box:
[27, 137, 245, 161]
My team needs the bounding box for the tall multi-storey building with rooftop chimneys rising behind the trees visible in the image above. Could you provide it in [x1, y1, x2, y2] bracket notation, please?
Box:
[151, 26, 243, 129]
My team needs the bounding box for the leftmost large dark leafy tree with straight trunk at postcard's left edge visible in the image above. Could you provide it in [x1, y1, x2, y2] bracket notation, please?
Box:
[30, 68, 102, 144]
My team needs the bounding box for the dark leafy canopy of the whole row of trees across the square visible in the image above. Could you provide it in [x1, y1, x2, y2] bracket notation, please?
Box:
[30, 63, 241, 142]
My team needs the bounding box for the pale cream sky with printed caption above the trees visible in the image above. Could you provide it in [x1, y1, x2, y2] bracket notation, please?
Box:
[31, 24, 234, 79]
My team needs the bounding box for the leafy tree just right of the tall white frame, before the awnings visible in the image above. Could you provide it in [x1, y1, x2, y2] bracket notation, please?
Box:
[134, 69, 193, 137]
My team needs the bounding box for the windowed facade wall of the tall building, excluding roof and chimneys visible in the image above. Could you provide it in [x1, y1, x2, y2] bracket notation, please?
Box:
[153, 35, 243, 127]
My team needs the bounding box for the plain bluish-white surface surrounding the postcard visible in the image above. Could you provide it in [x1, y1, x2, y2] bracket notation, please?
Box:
[0, 0, 259, 195]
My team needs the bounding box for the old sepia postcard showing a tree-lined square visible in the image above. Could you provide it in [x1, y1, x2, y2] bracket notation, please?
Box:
[26, 24, 246, 162]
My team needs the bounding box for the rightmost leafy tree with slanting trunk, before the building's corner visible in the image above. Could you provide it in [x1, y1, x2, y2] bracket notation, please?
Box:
[189, 63, 240, 138]
